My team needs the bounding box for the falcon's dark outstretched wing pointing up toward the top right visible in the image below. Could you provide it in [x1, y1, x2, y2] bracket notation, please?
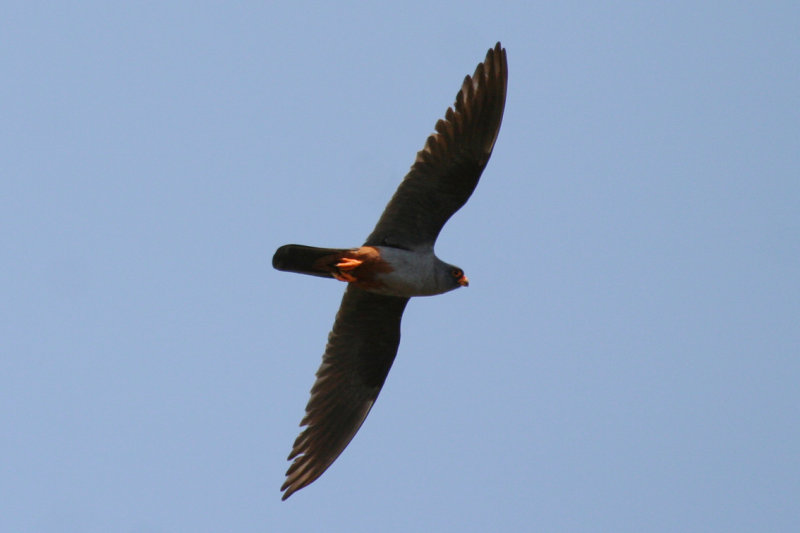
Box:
[364, 43, 508, 249]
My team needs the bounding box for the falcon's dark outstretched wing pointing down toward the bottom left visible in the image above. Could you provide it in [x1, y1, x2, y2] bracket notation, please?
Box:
[281, 284, 408, 500]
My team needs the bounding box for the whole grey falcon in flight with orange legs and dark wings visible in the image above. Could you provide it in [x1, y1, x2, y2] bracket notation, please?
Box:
[272, 42, 508, 500]
